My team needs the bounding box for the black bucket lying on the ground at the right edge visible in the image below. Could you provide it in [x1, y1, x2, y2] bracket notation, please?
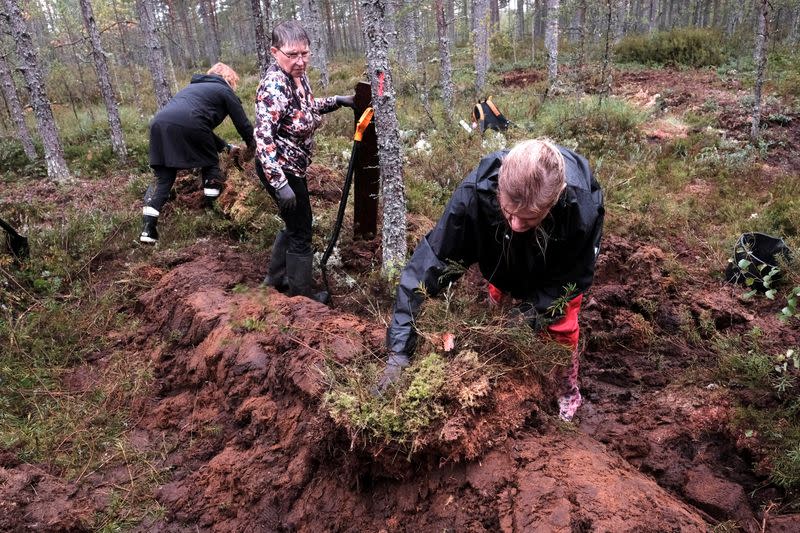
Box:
[725, 233, 792, 292]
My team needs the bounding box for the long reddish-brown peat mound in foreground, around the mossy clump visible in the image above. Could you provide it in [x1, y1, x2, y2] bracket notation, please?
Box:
[133, 243, 707, 531]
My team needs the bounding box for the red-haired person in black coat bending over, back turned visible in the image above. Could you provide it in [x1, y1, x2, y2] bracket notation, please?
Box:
[139, 63, 255, 244]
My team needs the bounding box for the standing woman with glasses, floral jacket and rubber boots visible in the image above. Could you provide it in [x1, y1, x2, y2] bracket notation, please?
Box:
[254, 21, 353, 302]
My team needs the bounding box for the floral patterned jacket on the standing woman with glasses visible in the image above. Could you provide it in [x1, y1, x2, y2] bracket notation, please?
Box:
[254, 64, 339, 189]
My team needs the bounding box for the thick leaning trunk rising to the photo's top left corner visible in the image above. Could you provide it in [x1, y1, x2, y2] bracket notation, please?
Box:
[0, 0, 70, 183]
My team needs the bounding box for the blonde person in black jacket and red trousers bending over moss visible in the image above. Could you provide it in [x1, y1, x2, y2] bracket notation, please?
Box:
[378, 140, 605, 420]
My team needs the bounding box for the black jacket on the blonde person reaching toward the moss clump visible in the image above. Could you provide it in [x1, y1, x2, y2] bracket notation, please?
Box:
[386, 147, 605, 355]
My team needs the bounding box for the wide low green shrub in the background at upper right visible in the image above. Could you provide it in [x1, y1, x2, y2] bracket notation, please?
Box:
[614, 28, 727, 67]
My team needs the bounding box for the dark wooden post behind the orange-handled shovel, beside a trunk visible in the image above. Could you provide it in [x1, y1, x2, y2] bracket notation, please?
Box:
[353, 81, 380, 240]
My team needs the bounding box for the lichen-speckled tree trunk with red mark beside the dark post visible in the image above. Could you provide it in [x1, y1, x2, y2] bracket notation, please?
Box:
[361, 0, 406, 277]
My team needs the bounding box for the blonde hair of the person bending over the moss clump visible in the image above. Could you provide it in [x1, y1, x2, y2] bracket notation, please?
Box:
[497, 139, 566, 217]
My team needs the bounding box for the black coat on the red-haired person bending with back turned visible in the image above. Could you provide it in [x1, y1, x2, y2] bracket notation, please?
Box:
[150, 74, 255, 168]
